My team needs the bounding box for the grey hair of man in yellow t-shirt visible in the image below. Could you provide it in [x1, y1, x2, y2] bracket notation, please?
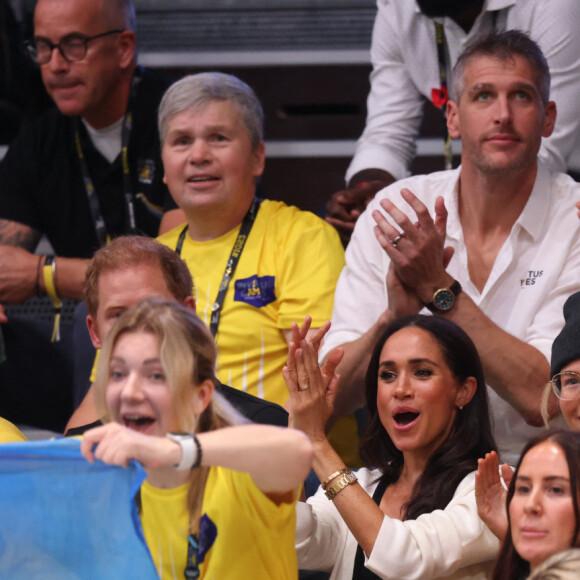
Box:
[158, 72, 264, 149]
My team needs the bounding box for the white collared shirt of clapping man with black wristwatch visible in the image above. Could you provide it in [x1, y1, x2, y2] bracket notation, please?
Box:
[321, 163, 580, 463]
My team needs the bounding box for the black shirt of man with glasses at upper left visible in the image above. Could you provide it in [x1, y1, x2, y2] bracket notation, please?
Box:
[0, 67, 177, 258]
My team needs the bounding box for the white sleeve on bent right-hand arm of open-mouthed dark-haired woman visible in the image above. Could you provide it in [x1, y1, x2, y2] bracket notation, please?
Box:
[365, 472, 499, 580]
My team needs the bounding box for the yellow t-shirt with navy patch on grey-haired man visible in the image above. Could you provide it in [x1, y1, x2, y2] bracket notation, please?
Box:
[159, 200, 344, 405]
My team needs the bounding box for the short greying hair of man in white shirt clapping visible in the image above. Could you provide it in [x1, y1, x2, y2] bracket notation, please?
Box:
[453, 30, 550, 105]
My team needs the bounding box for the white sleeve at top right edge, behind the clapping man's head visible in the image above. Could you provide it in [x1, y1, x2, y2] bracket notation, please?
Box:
[527, 0, 580, 171]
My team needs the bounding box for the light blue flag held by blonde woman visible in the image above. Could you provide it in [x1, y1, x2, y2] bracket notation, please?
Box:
[0, 439, 159, 580]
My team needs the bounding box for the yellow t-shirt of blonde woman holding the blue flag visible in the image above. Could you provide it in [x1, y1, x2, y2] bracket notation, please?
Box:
[141, 467, 298, 580]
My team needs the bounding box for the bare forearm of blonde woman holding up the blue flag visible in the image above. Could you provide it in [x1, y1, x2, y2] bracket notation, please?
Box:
[198, 425, 312, 493]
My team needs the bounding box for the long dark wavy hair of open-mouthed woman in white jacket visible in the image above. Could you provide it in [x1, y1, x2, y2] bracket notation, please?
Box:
[360, 314, 496, 520]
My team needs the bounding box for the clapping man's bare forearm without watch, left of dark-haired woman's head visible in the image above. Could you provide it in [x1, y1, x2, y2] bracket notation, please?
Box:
[333, 310, 394, 417]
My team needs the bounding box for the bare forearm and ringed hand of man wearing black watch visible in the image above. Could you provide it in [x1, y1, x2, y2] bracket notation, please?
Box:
[373, 189, 550, 426]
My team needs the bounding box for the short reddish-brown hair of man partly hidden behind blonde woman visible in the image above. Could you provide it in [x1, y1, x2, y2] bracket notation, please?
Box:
[84, 236, 193, 317]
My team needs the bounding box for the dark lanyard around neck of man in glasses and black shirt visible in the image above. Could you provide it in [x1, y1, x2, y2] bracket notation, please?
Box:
[74, 69, 141, 248]
